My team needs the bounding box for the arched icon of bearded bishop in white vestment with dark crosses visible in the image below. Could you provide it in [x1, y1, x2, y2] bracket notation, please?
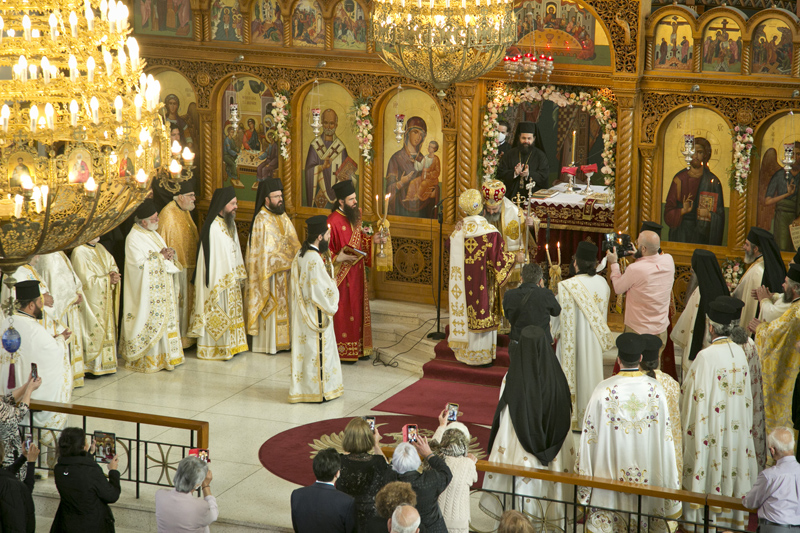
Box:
[301, 82, 361, 209]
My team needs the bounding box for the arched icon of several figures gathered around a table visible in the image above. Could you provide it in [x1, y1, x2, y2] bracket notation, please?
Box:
[221, 76, 280, 202]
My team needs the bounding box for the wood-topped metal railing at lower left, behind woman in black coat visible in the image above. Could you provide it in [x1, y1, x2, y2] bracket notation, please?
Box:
[26, 400, 209, 498]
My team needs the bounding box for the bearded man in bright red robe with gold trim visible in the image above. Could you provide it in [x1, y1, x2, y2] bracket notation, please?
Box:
[328, 180, 372, 362]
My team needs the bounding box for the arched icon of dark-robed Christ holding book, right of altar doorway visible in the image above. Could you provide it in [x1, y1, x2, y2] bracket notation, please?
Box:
[661, 108, 733, 246]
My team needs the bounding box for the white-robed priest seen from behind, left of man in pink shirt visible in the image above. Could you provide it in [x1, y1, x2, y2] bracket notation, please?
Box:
[550, 241, 614, 431]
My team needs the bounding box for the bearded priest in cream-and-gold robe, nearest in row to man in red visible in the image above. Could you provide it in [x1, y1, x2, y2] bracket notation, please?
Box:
[245, 178, 300, 354]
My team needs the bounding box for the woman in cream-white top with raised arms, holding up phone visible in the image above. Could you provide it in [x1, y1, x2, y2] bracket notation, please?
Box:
[431, 408, 478, 533]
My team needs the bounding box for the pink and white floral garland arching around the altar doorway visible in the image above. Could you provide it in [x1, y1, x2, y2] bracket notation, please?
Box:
[482, 85, 617, 188]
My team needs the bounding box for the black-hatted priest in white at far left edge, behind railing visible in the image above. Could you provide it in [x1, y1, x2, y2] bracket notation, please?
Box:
[0, 281, 72, 447]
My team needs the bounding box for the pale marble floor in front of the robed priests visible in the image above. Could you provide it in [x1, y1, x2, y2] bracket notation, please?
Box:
[36, 344, 418, 531]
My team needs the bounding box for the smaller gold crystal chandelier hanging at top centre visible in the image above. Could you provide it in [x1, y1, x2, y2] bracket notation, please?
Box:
[371, 0, 517, 98]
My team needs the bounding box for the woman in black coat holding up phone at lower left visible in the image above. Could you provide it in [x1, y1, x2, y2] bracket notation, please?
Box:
[50, 428, 120, 533]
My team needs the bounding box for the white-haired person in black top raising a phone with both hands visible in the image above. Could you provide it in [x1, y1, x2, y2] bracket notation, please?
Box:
[386, 436, 453, 533]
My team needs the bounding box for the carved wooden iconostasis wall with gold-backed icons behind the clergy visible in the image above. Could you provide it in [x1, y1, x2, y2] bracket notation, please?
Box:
[130, 0, 800, 303]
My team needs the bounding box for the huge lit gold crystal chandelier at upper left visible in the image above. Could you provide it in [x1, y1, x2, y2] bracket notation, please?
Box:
[0, 0, 189, 272]
